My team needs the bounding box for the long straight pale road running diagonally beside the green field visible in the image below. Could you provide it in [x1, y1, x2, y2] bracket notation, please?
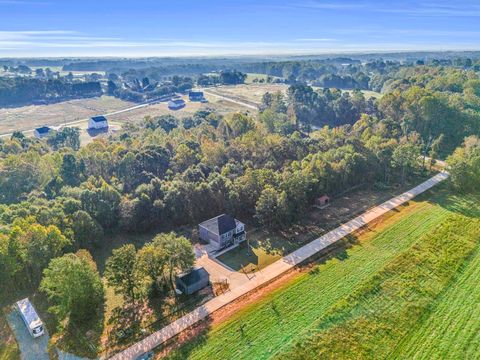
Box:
[111, 172, 448, 360]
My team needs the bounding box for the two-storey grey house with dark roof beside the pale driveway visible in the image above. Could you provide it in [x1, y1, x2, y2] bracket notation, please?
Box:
[198, 214, 247, 250]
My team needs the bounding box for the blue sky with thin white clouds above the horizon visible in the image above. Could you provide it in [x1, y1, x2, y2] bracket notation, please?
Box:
[0, 0, 480, 57]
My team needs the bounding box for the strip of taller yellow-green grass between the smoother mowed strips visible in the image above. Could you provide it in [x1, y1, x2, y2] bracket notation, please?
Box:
[279, 215, 480, 360]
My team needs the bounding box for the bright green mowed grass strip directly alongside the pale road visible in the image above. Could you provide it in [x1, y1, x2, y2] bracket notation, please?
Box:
[170, 189, 479, 359]
